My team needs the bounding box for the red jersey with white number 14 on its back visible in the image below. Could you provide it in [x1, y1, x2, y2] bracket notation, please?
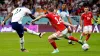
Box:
[46, 13, 66, 31]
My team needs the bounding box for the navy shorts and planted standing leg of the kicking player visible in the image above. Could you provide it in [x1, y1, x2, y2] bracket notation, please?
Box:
[11, 22, 26, 52]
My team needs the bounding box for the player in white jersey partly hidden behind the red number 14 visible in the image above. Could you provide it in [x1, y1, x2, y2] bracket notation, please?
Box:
[57, 3, 75, 44]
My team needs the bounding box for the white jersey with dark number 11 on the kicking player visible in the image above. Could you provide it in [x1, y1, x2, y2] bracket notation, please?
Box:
[11, 7, 32, 24]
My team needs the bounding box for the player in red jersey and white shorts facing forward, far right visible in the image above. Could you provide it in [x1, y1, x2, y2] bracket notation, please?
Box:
[80, 6, 95, 43]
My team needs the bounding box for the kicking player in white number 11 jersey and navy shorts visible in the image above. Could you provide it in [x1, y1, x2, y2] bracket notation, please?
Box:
[1, 2, 42, 52]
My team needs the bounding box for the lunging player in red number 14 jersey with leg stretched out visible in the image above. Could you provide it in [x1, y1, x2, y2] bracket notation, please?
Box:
[32, 8, 83, 53]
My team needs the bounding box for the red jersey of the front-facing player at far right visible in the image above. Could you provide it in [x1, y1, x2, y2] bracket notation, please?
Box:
[81, 12, 93, 26]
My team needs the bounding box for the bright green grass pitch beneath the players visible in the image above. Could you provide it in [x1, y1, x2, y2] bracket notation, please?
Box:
[0, 33, 100, 56]
